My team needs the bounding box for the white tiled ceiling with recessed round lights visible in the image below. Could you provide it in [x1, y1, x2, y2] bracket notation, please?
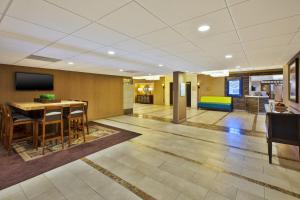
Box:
[0, 0, 300, 76]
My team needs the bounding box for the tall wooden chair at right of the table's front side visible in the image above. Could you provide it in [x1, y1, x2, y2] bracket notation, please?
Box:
[65, 104, 85, 146]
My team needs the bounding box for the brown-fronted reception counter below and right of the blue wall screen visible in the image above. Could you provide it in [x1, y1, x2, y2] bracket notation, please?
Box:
[245, 95, 269, 113]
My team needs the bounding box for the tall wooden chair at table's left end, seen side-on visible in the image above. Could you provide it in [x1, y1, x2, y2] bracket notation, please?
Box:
[3, 105, 36, 152]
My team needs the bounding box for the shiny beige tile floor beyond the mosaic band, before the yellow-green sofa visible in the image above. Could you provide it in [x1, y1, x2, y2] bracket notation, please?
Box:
[133, 104, 265, 132]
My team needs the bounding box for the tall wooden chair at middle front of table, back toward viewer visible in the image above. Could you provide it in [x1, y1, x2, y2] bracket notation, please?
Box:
[35, 106, 64, 155]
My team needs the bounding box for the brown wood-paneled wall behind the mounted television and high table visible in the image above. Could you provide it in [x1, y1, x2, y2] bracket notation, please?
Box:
[0, 65, 123, 120]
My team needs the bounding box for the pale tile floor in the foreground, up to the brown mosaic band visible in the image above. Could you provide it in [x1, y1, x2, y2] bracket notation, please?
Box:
[0, 115, 300, 200]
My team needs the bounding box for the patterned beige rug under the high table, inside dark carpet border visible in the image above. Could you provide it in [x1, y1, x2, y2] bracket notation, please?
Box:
[13, 124, 120, 161]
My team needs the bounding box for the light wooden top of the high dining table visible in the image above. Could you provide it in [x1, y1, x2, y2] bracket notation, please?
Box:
[9, 100, 86, 111]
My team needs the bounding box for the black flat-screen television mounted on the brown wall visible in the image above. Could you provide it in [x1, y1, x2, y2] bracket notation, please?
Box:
[16, 72, 53, 91]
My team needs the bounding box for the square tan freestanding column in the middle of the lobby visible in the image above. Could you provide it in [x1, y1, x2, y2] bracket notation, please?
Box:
[173, 71, 186, 124]
